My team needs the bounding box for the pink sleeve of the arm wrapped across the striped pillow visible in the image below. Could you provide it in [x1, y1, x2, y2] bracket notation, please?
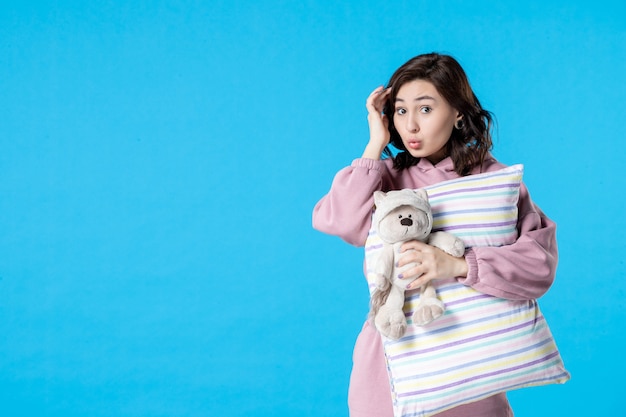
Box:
[460, 184, 558, 300]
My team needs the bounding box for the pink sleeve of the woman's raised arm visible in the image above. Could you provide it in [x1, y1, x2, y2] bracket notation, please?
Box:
[313, 158, 386, 246]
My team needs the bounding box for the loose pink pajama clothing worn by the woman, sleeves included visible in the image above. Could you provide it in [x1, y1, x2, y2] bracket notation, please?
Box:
[313, 156, 558, 417]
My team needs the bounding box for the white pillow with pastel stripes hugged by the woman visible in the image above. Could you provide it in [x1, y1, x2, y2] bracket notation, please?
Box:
[365, 165, 569, 417]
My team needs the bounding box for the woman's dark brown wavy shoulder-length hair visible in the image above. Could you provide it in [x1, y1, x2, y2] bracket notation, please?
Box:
[383, 53, 493, 176]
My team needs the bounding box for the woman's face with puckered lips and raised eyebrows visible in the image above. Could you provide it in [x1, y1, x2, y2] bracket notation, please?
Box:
[393, 80, 461, 164]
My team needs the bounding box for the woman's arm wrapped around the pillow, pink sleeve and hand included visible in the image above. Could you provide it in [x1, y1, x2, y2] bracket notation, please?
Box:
[398, 185, 558, 300]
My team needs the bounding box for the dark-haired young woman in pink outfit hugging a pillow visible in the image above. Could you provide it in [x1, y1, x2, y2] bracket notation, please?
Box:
[313, 53, 558, 417]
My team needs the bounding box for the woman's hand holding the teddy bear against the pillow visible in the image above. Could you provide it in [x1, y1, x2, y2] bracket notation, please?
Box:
[397, 240, 467, 290]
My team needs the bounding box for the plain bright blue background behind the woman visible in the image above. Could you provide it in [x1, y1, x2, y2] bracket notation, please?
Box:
[0, 0, 626, 417]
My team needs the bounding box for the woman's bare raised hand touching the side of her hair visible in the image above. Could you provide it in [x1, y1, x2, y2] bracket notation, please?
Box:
[363, 86, 391, 159]
